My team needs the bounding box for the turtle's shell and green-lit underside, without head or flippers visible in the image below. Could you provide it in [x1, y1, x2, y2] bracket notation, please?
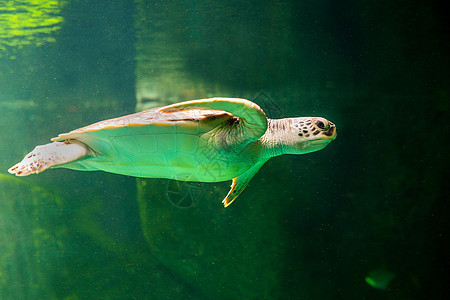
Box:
[52, 108, 248, 182]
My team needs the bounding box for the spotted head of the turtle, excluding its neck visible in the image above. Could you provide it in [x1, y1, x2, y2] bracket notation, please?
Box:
[285, 117, 336, 154]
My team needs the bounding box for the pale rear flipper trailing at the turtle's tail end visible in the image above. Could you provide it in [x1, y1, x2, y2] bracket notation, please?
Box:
[8, 140, 90, 176]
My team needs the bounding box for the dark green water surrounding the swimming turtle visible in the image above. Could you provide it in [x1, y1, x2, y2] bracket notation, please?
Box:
[0, 0, 450, 299]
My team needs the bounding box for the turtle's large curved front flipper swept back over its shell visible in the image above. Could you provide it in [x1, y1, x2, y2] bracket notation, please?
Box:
[158, 98, 267, 143]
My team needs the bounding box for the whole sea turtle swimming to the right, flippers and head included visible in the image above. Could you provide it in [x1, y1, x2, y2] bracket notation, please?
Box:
[8, 98, 336, 206]
